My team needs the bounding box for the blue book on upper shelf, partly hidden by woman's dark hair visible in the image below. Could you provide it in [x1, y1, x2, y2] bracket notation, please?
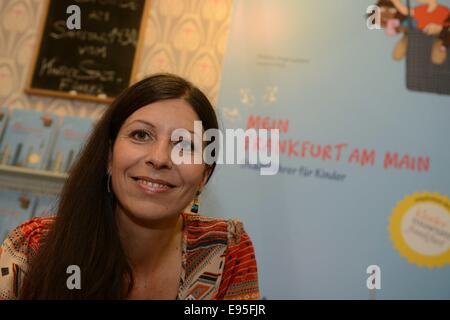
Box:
[48, 116, 93, 173]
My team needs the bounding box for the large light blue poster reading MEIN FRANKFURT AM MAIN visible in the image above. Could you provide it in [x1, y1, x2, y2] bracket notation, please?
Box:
[205, 0, 450, 299]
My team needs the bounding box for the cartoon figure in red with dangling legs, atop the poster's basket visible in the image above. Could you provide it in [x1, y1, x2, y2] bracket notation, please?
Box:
[390, 0, 450, 64]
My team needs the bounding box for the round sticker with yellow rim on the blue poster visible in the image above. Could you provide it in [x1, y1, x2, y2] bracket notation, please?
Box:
[389, 192, 450, 268]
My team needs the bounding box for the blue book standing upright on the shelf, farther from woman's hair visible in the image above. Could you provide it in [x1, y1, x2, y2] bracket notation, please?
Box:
[0, 109, 58, 169]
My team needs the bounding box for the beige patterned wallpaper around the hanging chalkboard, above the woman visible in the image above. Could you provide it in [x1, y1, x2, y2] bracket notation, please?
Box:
[0, 0, 232, 118]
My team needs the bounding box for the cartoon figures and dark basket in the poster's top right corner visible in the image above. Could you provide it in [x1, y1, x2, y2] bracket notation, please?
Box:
[367, 0, 450, 95]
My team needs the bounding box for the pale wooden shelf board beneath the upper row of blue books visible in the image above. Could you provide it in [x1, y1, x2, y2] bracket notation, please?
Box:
[0, 165, 68, 194]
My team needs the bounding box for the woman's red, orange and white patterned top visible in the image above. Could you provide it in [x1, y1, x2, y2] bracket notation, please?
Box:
[0, 213, 260, 300]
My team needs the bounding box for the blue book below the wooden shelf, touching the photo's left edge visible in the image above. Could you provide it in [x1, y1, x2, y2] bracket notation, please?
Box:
[0, 189, 37, 242]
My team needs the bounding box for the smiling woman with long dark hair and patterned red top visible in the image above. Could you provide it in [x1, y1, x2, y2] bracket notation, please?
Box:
[0, 74, 259, 299]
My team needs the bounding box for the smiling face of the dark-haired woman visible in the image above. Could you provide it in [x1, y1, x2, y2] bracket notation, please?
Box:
[109, 99, 208, 222]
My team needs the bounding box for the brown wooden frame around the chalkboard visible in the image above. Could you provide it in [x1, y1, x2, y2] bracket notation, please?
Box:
[24, 0, 151, 104]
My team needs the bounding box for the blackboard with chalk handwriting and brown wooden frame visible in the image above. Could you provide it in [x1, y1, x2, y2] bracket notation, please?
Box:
[25, 0, 149, 102]
